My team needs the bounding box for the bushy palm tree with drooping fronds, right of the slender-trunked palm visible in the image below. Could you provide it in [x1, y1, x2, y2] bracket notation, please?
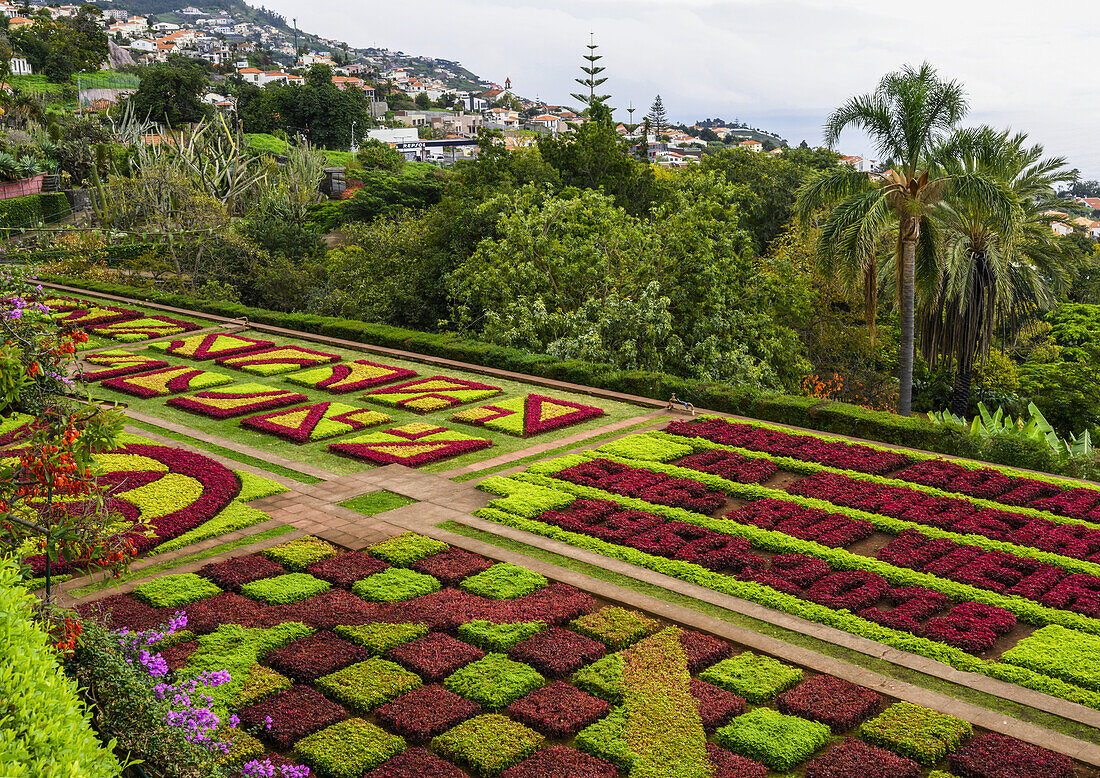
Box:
[917, 128, 1075, 417]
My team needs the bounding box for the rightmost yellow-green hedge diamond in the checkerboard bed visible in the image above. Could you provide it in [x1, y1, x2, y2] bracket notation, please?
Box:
[859, 702, 974, 767]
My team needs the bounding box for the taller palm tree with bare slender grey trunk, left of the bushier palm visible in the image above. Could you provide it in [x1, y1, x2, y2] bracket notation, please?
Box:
[796, 63, 1014, 416]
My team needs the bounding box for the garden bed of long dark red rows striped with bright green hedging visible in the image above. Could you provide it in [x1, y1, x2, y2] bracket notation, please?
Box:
[476, 418, 1100, 709]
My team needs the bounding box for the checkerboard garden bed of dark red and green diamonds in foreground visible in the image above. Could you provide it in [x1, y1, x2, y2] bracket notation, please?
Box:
[70, 534, 1098, 778]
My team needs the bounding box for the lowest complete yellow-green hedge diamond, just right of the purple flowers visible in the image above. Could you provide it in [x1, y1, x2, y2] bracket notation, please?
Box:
[294, 719, 405, 778]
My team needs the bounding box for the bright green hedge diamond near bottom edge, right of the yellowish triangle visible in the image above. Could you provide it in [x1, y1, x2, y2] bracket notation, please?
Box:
[715, 708, 829, 772]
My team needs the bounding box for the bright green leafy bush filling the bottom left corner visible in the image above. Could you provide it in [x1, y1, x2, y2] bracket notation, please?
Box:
[0, 560, 121, 778]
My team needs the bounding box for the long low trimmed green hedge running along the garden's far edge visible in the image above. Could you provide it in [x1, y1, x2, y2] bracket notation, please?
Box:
[38, 276, 1034, 467]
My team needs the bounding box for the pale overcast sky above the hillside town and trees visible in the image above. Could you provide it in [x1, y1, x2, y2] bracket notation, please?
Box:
[261, 0, 1100, 178]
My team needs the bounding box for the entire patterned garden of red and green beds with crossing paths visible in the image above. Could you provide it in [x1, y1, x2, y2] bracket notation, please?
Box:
[15, 291, 1100, 778]
